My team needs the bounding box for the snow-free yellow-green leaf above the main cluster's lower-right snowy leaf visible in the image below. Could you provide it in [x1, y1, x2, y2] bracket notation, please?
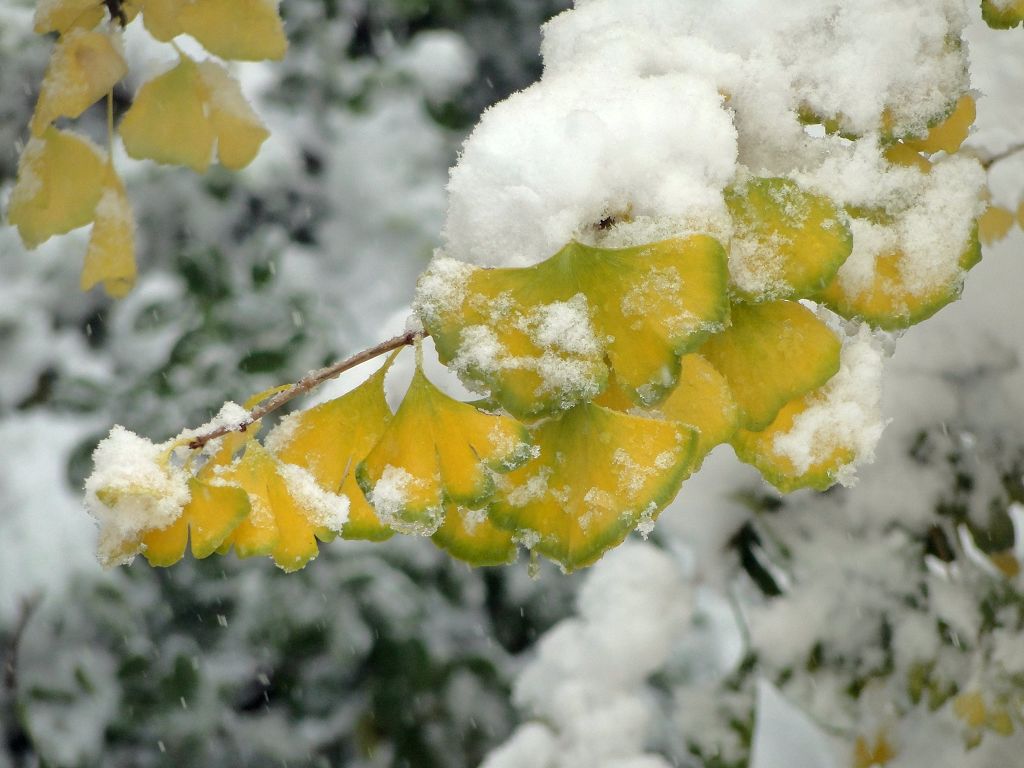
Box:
[700, 301, 841, 430]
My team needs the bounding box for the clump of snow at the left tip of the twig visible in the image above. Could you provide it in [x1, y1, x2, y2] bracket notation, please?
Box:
[85, 425, 189, 565]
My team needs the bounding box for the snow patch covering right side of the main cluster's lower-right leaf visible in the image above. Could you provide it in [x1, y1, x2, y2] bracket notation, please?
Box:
[773, 327, 886, 485]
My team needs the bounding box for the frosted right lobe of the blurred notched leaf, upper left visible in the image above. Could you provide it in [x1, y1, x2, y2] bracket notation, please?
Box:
[199, 61, 270, 171]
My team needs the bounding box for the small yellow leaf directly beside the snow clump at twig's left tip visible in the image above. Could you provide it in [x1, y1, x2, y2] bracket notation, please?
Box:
[142, 478, 250, 566]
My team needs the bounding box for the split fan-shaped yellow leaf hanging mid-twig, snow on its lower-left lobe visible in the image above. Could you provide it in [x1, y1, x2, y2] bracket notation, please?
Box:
[356, 366, 530, 536]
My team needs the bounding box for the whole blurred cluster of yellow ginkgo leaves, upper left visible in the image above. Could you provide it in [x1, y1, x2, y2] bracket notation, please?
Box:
[8, 0, 288, 297]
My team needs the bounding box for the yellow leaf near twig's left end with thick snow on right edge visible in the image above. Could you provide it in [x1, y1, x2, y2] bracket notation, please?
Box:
[216, 439, 348, 571]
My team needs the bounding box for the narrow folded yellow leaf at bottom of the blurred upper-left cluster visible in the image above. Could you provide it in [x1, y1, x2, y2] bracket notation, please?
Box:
[81, 166, 135, 299]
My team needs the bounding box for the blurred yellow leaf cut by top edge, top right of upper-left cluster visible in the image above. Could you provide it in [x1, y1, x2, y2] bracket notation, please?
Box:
[177, 0, 288, 61]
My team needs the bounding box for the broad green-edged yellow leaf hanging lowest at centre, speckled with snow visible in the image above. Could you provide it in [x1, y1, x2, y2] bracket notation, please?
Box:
[489, 403, 697, 570]
